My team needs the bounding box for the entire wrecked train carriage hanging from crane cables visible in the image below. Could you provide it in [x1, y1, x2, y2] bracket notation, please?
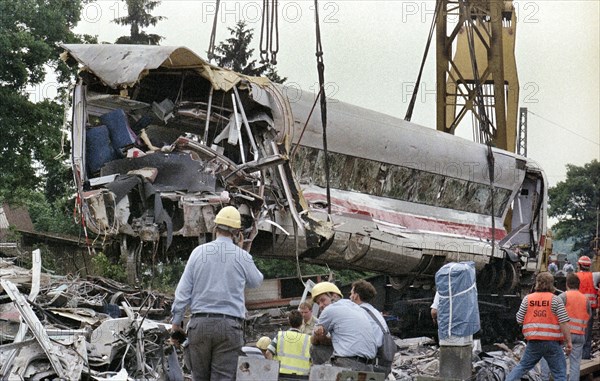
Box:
[66, 45, 547, 293]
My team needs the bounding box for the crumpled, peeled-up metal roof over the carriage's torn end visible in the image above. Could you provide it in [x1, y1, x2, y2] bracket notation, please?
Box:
[61, 44, 270, 91]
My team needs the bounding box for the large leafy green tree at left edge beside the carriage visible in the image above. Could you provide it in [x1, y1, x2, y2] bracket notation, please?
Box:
[0, 0, 89, 202]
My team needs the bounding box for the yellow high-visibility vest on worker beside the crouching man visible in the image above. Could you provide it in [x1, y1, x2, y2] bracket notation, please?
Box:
[275, 330, 310, 375]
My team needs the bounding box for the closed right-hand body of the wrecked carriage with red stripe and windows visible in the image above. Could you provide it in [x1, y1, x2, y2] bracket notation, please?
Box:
[254, 92, 547, 297]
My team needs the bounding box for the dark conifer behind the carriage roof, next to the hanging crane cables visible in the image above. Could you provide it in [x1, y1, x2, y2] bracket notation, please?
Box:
[209, 21, 287, 83]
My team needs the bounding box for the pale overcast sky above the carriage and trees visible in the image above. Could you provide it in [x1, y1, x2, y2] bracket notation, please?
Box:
[69, 0, 600, 186]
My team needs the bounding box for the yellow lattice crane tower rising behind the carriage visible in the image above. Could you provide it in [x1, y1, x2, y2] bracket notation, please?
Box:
[436, 0, 519, 152]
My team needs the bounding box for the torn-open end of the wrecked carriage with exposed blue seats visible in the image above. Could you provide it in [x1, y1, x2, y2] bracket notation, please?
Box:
[63, 45, 332, 280]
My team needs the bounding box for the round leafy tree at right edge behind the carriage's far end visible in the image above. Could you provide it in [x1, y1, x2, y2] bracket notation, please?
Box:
[548, 160, 600, 256]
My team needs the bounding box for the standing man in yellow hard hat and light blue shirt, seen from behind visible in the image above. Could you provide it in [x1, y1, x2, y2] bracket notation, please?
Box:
[171, 206, 263, 381]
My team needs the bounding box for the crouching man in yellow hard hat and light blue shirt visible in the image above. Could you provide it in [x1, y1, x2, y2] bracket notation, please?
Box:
[311, 282, 377, 372]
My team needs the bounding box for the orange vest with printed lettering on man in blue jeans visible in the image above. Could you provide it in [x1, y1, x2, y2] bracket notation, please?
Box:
[523, 292, 563, 341]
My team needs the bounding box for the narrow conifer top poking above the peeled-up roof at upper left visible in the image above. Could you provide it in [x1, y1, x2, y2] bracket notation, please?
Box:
[113, 0, 165, 45]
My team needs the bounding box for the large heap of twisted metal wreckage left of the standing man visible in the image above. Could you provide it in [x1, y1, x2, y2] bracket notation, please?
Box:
[0, 250, 178, 380]
